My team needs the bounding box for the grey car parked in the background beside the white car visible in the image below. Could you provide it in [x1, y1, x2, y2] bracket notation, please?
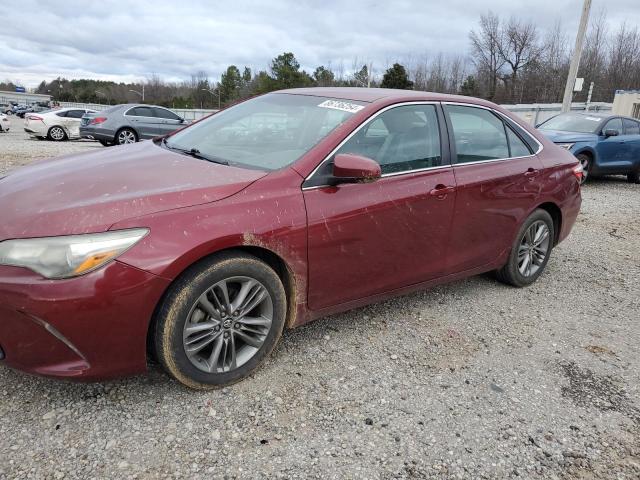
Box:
[80, 104, 186, 146]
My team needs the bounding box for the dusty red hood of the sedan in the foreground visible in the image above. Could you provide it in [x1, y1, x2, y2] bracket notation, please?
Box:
[0, 141, 266, 240]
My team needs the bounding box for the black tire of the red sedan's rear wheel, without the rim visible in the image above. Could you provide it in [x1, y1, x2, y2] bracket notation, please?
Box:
[496, 209, 555, 288]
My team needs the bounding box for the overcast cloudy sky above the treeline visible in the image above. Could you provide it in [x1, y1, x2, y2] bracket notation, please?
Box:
[0, 0, 640, 87]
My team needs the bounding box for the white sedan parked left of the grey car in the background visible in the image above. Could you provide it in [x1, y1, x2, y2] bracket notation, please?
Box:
[24, 107, 95, 142]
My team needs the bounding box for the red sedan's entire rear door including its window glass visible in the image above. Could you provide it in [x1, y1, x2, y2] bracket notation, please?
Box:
[444, 104, 543, 273]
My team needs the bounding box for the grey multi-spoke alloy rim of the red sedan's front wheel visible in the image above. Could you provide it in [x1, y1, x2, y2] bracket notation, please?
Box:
[183, 277, 274, 373]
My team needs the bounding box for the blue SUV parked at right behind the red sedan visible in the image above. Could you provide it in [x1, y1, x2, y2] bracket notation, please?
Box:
[538, 112, 640, 183]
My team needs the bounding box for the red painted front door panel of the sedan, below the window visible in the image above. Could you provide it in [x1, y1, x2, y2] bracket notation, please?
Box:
[304, 167, 455, 310]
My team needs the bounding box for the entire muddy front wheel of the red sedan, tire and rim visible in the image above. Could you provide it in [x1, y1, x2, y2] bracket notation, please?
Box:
[154, 252, 287, 389]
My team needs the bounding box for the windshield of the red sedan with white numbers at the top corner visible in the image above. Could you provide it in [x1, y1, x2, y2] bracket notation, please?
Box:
[165, 93, 364, 170]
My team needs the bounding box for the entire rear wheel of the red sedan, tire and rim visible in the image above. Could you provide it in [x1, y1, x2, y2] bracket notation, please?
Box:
[496, 209, 555, 287]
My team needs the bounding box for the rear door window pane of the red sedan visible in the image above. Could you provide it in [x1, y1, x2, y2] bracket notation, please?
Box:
[445, 105, 510, 163]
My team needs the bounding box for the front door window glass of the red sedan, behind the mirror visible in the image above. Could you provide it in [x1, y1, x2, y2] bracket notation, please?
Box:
[336, 105, 442, 174]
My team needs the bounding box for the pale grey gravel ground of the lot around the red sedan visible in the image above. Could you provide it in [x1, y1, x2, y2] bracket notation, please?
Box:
[0, 114, 640, 479]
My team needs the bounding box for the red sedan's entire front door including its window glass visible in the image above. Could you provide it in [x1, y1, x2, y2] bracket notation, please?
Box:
[304, 104, 455, 310]
